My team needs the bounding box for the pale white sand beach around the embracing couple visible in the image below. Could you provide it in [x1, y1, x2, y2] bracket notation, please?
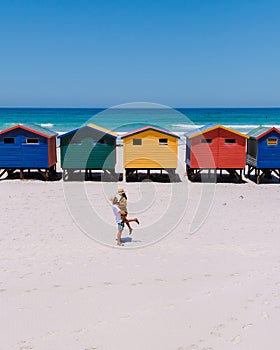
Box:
[0, 149, 280, 350]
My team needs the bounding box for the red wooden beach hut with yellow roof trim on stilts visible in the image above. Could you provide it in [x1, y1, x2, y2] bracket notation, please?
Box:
[185, 125, 248, 181]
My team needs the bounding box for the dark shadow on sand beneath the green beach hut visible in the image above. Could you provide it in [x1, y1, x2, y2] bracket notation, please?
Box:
[62, 170, 122, 182]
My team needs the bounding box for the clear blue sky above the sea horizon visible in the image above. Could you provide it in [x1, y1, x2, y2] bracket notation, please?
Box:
[0, 0, 280, 107]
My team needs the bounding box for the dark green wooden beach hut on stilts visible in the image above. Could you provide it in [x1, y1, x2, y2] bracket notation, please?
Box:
[58, 124, 118, 179]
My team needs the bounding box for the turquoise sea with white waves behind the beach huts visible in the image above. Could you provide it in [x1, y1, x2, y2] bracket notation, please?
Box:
[0, 108, 280, 133]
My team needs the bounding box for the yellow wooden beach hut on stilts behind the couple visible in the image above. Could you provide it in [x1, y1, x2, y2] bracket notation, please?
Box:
[122, 126, 179, 178]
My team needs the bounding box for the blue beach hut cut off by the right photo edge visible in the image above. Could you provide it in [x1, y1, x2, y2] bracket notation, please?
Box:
[246, 126, 280, 183]
